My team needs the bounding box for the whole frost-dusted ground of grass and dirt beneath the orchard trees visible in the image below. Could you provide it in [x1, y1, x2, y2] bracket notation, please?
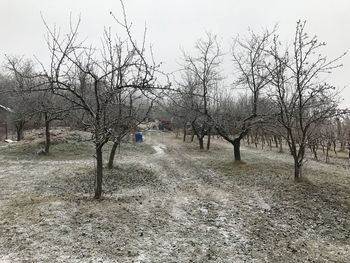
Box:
[0, 132, 350, 263]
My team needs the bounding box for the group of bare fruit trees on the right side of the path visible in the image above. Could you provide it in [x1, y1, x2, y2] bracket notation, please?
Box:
[169, 21, 347, 180]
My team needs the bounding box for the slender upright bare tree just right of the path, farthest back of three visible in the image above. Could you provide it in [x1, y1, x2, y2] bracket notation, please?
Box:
[181, 33, 222, 149]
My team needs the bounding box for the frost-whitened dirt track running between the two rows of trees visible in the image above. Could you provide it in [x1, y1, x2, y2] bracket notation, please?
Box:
[117, 135, 270, 262]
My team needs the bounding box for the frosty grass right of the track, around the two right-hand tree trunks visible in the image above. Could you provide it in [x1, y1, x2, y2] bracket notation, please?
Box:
[191, 139, 350, 262]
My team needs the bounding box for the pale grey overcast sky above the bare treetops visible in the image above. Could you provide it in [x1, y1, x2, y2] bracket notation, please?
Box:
[0, 0, 350, 108]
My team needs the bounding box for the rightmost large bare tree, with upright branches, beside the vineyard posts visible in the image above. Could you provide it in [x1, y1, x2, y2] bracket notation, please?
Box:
[267, 21, 344, 180]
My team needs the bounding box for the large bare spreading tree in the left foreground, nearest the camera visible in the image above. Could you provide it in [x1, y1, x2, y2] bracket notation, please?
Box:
[39, 7, 164, 199]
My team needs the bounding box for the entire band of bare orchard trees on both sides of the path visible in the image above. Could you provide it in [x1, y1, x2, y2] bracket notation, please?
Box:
[0, 13, 348, 198]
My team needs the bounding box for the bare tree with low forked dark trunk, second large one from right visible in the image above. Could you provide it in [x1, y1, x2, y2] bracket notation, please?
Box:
[215, 30, 273, 161]
